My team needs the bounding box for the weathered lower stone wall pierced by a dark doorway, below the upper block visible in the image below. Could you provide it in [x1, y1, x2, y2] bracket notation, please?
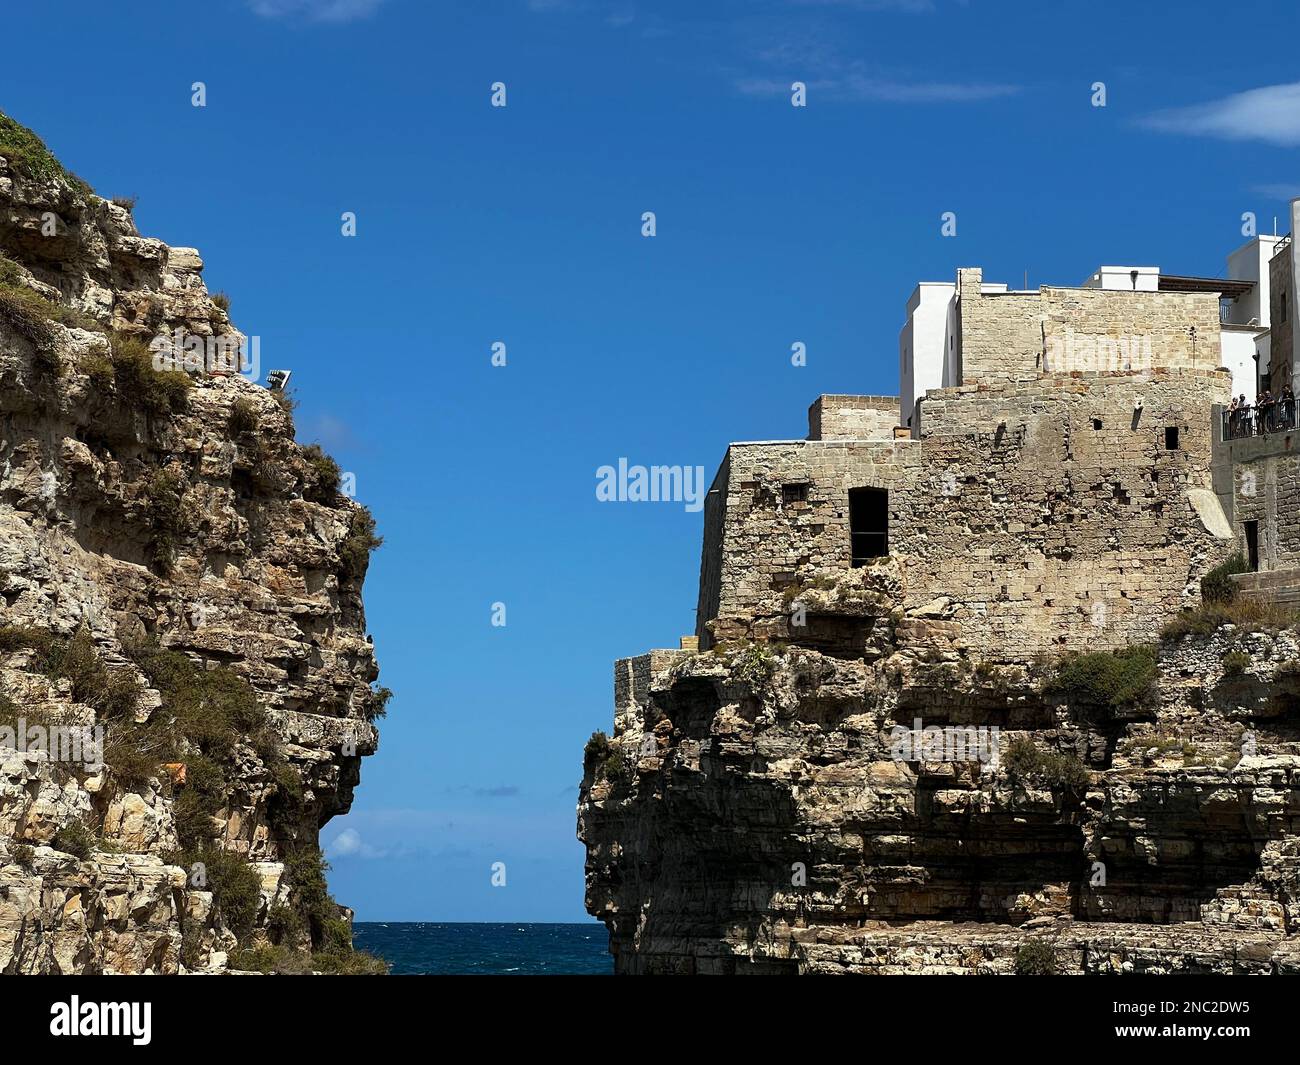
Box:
[698, 371, 1231, 658]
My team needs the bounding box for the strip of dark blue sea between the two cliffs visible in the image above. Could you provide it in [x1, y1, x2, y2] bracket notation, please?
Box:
[352, 921, 614, 977]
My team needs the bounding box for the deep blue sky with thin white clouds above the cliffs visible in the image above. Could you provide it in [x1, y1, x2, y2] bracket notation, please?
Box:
[0, 0, 1300, 921]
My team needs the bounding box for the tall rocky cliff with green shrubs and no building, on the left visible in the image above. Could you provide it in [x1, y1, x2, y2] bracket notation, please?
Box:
[0, 116, 384, 973]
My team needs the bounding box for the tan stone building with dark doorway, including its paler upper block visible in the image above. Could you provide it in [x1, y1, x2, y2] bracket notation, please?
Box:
[696, 269, 1234, 659]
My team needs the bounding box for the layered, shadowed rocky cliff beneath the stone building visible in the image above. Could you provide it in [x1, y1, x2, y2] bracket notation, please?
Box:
[579, 527, 1300, 973]
